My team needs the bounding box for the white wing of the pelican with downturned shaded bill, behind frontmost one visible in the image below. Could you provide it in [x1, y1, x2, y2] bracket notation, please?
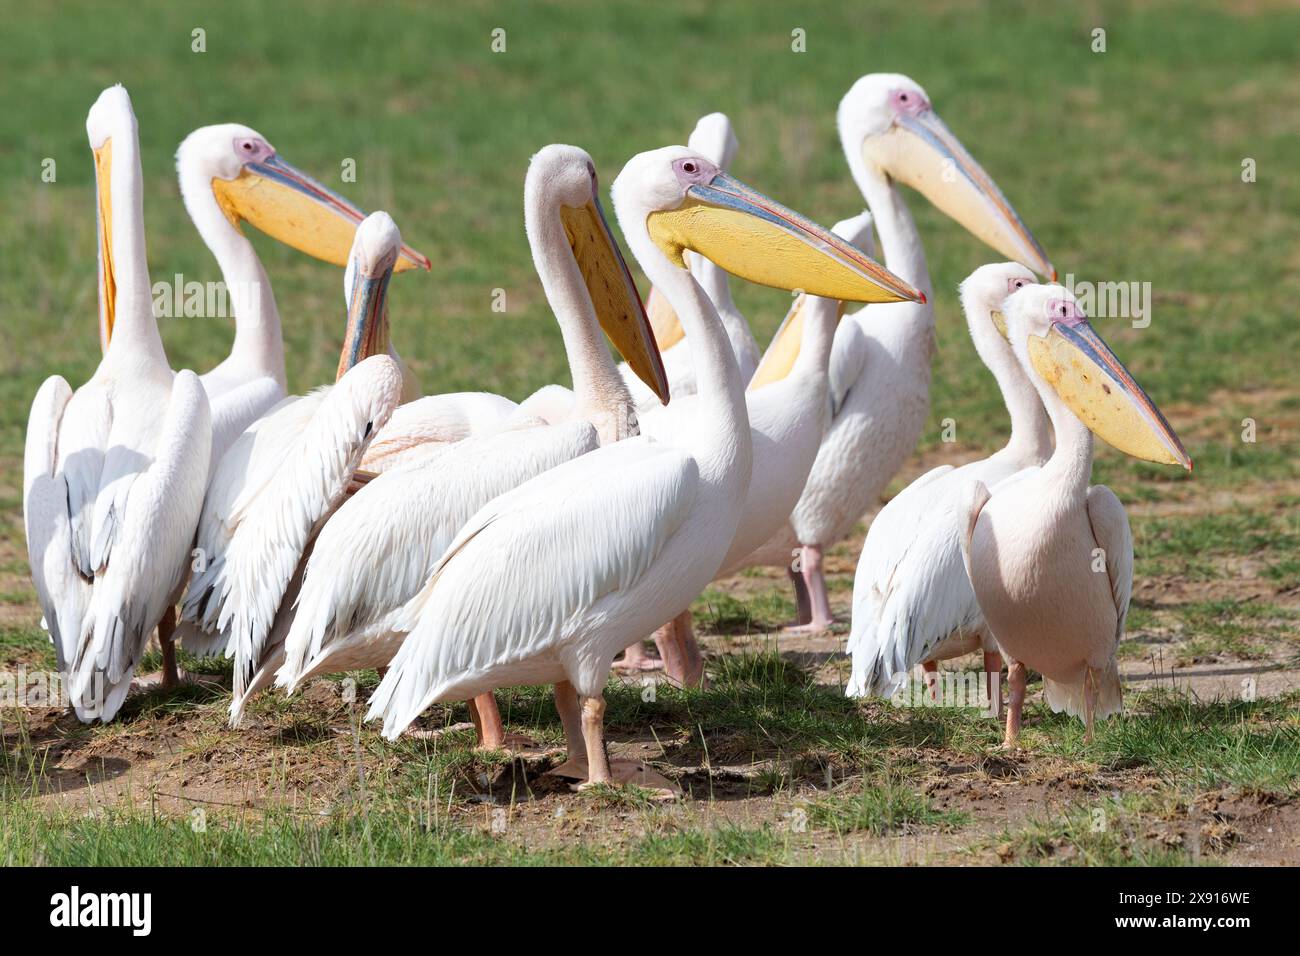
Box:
[277, 421, 599, 691]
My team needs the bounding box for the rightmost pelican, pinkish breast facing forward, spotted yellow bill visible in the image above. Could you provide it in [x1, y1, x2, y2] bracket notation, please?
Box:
[961, 285, 1192, 747]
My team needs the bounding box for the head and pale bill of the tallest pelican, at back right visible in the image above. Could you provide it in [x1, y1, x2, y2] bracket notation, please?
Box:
[839, 73, 1056, 280]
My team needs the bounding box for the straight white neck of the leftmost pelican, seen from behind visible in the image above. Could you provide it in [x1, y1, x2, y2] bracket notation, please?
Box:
[104, 114, 169, 369]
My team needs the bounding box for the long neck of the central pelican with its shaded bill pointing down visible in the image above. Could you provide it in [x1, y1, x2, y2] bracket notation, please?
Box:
[524, 195, 633, 444]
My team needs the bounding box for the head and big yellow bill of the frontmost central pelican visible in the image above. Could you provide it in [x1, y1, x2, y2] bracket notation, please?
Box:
[612, 146, 926, 302]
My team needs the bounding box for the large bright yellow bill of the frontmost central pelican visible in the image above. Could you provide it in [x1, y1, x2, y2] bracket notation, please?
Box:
[646, 173, 926, 302]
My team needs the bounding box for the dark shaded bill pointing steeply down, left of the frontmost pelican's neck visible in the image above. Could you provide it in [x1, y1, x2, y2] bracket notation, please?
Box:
[560, 196, 671, 405]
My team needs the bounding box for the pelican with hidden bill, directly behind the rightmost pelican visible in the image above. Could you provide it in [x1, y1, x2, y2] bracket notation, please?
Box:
[846, 263, 1052, 697]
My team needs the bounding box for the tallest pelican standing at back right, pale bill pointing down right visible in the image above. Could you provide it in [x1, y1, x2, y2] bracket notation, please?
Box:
[746, 73, 1056, 631]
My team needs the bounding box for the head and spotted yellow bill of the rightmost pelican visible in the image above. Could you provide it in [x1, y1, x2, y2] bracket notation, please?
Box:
[1002, 284, 1192, 471]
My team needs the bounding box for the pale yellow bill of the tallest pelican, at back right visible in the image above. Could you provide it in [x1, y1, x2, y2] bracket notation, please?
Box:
[862, 109, 1056, 281]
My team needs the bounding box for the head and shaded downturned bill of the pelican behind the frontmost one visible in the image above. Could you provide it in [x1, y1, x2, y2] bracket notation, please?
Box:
[524, 143, 668, 402]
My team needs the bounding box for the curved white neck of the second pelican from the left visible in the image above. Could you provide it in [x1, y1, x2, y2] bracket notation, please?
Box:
[179, 165, 285, 388]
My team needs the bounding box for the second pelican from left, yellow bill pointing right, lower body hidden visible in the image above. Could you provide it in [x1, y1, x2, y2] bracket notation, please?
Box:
[176, 122, 429, 466]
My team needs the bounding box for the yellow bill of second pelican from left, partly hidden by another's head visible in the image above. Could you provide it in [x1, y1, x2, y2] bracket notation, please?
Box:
[212, 156, 430, 272]
